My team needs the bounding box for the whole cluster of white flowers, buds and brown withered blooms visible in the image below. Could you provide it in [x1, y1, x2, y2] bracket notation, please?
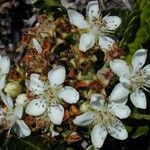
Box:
[0, 1, 150, 149]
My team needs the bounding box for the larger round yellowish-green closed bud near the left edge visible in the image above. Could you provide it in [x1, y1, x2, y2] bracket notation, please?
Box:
[4, 81, 21, 97]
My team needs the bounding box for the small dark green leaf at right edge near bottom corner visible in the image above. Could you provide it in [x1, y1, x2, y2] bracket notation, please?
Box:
[132, 126, 149, 139]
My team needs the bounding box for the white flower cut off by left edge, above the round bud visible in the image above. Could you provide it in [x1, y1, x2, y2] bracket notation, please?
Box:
[0, 55, 10, 92]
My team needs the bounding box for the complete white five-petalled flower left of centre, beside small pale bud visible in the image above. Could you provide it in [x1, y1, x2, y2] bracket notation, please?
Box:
[26, 66, 79, 125]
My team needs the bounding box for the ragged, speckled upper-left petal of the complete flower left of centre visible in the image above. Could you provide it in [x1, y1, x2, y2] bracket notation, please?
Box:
[26, 73, 45, 95]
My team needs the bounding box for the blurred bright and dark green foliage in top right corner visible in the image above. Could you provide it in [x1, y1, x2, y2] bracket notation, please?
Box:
[120, 0, 150, 62]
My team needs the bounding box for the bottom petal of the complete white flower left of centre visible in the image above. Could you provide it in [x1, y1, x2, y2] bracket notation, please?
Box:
[48, 104, 64, 125]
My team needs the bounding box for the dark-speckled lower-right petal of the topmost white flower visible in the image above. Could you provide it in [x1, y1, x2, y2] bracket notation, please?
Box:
[99, 35, 115, 50]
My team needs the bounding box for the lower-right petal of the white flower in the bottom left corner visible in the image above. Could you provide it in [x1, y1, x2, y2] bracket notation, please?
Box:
[16, 120, 31, 137]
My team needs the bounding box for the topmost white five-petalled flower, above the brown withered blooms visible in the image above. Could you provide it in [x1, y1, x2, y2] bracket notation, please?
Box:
[68, 1, 121, 52]
